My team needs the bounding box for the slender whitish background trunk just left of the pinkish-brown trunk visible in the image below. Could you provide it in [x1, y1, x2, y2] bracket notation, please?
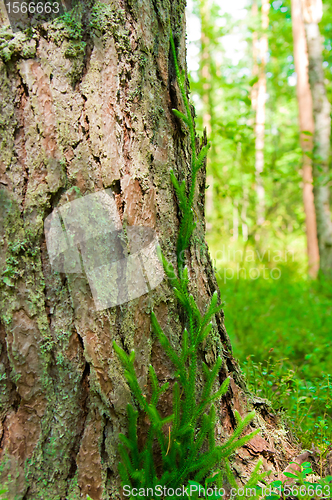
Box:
[252, 0, 270, 226]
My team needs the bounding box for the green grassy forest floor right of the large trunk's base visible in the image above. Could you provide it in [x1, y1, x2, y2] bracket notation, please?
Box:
[208, 233, 332, 459]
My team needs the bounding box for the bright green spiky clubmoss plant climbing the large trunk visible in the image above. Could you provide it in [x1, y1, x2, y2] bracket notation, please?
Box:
[114, 35, 258, 499]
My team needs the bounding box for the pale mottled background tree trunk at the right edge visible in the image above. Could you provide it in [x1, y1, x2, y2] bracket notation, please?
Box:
[302, 0, 332, 277]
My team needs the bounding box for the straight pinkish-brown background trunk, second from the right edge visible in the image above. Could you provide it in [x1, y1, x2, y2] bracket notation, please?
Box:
[292, 0, 319, 278]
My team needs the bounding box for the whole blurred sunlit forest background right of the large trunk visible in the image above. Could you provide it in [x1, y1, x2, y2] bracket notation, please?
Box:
[187, 0, 332, 459]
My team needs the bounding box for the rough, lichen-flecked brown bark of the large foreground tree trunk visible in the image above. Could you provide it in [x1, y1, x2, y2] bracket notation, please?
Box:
[0, 0, 296, 500]
